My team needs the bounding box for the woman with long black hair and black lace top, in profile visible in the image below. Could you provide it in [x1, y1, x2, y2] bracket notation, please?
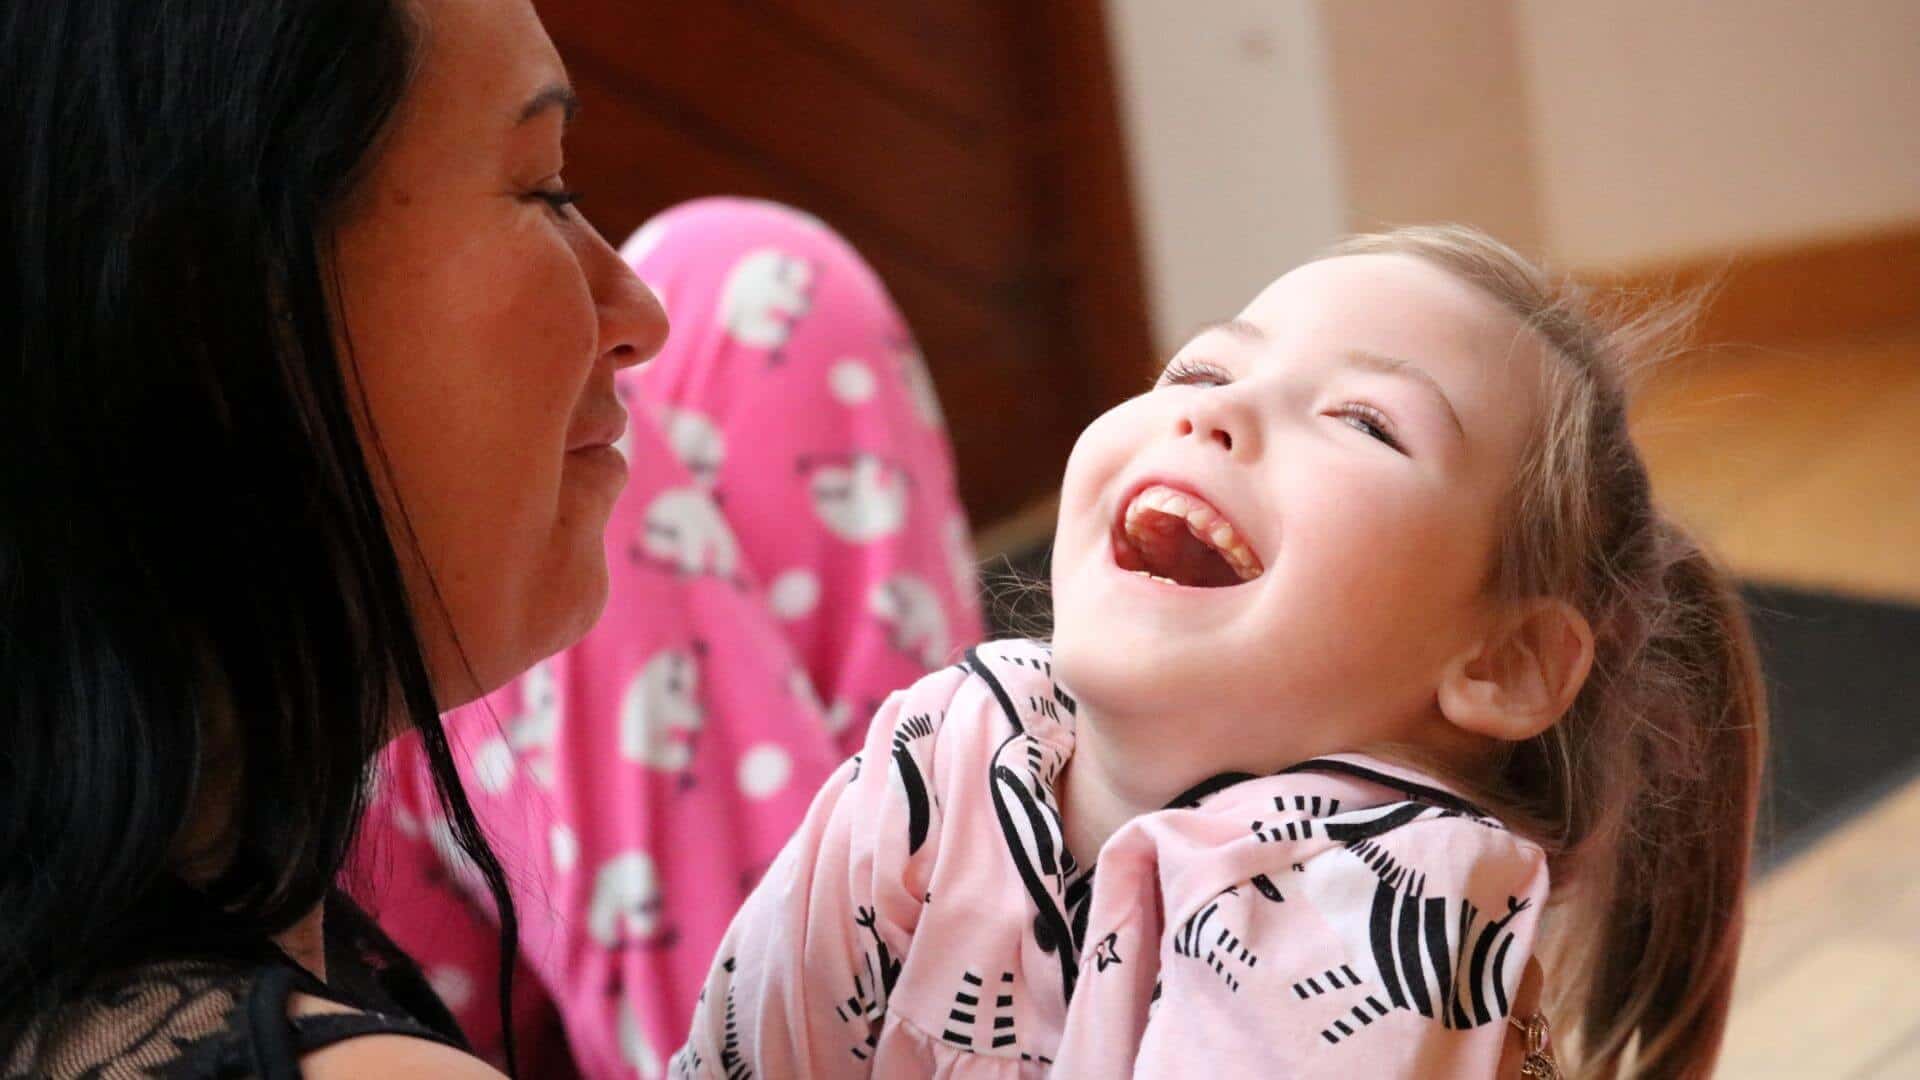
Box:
[0, 0, 666, 1076]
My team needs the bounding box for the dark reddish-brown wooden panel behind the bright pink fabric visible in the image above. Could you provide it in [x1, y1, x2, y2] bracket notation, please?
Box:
[541, 0, 1150, 525]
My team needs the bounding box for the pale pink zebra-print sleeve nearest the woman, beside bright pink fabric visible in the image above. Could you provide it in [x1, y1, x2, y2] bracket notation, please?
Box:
[672, 669, 966, 1076]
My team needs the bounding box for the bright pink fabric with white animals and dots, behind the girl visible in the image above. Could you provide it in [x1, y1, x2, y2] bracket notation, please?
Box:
[357, 200, 981, 1076]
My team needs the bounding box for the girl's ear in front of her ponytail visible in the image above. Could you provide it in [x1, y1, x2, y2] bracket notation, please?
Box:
[1440, 598, 1594, 742]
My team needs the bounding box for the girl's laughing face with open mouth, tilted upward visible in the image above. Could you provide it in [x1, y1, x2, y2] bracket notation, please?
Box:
[1054, 256, 1544, 774]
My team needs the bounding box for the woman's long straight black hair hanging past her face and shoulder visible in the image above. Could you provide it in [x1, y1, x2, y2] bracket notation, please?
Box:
[0, 0, 515, 1061]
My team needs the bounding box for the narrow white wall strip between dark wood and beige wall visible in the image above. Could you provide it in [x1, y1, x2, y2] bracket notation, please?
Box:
[1108, 0, 1346, 352]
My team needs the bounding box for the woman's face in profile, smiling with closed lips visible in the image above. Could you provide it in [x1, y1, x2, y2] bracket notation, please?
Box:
[336, 0, 666, 709]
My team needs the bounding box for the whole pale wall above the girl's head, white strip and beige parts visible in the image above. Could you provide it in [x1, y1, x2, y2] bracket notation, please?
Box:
[1106, 0, 1920, 286]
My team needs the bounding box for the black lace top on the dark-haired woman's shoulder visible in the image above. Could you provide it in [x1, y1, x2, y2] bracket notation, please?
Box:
[0, 892, 468, 1080]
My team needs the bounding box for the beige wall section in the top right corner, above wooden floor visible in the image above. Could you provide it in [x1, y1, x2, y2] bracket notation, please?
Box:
[1517, 0, 1920, 265]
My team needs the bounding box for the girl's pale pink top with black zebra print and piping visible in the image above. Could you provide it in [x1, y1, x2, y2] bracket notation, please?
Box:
[672, 642, 1548, 1080]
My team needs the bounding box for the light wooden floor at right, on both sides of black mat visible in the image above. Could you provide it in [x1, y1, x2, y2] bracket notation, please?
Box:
[1636, 332, 1920, 1078]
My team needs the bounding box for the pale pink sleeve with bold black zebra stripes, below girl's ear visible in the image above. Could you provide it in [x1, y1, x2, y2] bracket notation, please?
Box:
[1133, 817, 1548, 1078]
